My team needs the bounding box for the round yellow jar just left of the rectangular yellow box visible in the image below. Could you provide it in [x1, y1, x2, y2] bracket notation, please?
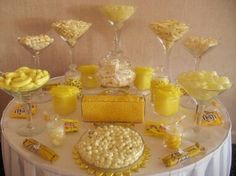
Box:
[50, 85, 80, 115]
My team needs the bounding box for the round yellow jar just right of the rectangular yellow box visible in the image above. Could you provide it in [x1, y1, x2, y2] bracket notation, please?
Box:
[154, 84, 181, 116]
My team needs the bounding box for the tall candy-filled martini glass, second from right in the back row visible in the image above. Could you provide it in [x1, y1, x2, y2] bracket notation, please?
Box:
[150, 20, 189, 82]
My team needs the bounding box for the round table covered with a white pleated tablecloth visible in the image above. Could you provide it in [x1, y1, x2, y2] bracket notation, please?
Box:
[1, 82, 231, 176]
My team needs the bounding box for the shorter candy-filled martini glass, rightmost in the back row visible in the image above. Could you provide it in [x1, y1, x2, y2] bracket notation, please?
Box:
[184, 37, 218, 71]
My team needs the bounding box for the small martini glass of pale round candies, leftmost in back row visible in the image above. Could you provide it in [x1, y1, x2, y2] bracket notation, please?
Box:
[18, 34, 54, 103]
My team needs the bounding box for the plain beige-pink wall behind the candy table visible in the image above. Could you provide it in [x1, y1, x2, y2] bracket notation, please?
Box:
[0, 0, 236, 142]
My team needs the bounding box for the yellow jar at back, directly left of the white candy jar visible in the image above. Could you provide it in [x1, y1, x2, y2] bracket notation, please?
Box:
[79, 65, 100, 88]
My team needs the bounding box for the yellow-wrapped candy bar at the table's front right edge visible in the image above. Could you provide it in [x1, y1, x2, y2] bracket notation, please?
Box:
[162, 143, 205, 167]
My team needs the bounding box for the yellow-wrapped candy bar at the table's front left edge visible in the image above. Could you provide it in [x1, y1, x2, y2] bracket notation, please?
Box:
[23, 138, 59, 161]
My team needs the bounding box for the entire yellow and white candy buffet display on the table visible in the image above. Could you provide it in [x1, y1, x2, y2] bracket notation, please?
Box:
[0, 5, 232, 176]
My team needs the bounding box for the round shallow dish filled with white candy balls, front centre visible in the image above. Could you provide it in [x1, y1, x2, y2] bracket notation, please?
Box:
[77, 125, 144, 169]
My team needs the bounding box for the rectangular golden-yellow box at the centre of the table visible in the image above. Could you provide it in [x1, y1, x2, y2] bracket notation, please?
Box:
[82, 95, 145, 123]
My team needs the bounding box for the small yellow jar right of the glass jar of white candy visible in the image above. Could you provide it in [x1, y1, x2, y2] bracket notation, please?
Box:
[134, 67, 153, 90]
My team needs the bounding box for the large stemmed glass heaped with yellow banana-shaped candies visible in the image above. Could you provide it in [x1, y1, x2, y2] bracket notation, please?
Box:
[0, 67, 50, 136]
